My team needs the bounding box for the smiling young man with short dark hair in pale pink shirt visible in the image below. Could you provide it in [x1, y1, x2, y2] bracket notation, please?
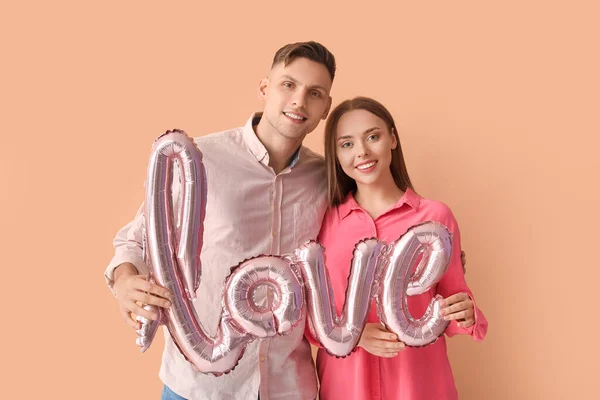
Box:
[105, 42, 335, 400]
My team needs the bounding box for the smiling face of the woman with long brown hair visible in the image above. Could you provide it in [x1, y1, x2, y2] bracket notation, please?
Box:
[336, 110, 398, 185]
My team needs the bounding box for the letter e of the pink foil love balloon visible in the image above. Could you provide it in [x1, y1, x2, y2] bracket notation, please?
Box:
[376, 222, 452, 347]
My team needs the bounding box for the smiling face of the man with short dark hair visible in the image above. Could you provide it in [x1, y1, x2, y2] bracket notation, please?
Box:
[259, 58, 332, 140]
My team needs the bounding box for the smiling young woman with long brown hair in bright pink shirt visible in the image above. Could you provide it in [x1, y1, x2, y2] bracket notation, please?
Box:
[307, 97, 487, 400]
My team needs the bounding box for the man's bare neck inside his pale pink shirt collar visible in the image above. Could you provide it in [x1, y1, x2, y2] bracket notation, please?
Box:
[253, 117, 302, 174]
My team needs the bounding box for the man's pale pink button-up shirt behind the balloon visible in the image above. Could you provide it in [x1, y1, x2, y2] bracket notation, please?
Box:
[105, 114, 326, 400]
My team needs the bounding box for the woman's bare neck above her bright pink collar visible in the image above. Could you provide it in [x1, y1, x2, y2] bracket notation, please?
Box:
[354, 175, 404, 219]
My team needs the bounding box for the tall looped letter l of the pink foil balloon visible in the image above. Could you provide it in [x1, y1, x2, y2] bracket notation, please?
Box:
[137, 131, 274, 375]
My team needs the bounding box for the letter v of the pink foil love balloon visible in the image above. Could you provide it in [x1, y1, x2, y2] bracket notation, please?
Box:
[296, 239, 384, 357]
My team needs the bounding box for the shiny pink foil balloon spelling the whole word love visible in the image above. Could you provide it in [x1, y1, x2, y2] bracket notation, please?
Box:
[137, 130, 452, 375]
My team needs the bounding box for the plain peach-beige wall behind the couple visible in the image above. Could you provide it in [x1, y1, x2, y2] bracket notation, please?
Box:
[0, 0, 600, 399]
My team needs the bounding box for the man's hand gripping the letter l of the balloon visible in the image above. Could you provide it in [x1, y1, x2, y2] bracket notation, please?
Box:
[113, 263, 171, 330]
